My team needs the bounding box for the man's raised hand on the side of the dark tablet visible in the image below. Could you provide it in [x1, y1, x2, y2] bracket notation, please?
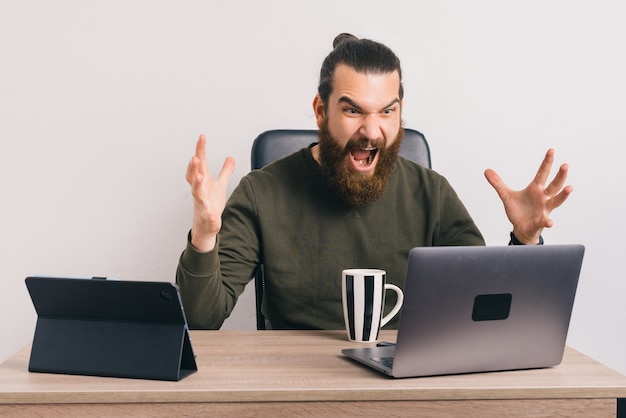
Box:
[186, 135, 235, 252]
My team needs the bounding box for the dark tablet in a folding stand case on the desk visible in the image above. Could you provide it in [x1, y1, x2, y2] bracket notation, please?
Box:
[26, 276, 197, 381]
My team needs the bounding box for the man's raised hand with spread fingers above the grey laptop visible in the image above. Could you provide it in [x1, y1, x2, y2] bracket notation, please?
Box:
[485, 149, 573, 244]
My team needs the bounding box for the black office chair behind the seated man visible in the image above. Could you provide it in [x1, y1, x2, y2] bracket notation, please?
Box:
[251, 129, 431, 330]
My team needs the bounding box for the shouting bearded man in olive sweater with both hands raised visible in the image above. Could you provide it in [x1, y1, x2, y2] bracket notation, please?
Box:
[176, 34, 572, 329]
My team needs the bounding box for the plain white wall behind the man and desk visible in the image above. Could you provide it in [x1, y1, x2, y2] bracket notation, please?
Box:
[0, 0, 626, 373]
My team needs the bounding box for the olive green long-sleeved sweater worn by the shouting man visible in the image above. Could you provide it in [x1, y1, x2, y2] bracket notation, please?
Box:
[176, 147, 484, 329]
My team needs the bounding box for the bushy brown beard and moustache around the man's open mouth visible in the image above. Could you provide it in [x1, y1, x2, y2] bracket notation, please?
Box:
[318, 122, 404, 207]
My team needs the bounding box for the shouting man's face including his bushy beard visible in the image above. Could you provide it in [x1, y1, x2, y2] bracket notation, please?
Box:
[313, 65, 404, 206]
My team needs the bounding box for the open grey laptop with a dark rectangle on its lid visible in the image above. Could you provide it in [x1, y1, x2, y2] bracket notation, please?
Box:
[342, 245, 584, 378]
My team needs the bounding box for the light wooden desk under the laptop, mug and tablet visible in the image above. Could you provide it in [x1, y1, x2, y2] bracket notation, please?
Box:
[0, 331, 626, 418]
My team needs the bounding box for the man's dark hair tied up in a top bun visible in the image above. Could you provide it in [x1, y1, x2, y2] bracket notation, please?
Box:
[317, 33, 404, 107]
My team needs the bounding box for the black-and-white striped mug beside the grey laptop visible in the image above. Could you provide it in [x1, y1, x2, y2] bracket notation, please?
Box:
[341, 269, 404, 342]
